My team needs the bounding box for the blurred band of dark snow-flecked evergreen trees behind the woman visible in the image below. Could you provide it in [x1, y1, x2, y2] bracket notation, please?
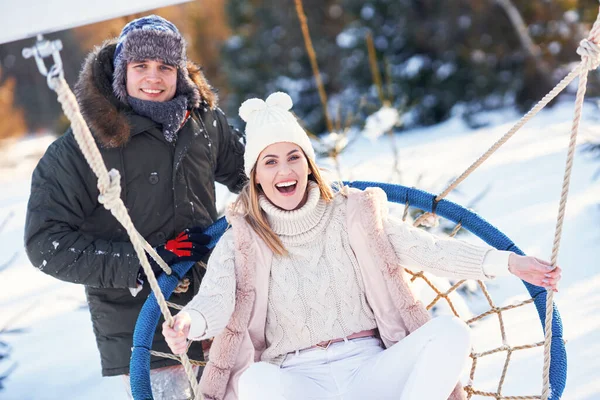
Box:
[223, 0, 598, 133]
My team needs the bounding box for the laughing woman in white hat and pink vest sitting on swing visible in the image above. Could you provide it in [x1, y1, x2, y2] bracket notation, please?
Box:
[163, 93, 560, 400]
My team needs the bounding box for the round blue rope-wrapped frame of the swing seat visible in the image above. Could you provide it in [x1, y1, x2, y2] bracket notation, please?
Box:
[130, 181, 567, 400]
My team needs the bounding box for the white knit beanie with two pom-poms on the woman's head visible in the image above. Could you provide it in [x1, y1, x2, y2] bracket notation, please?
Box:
[239, 92, 315, 176]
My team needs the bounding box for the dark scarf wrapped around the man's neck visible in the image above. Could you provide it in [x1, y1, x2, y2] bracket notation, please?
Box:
[127, 95, 188, 143]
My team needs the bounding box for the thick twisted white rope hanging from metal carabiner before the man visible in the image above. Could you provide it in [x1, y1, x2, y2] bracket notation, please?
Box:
[50, 76, 202, 399]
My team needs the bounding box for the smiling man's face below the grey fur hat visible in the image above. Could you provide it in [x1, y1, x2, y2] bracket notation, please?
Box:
[127, 60, 177, 101]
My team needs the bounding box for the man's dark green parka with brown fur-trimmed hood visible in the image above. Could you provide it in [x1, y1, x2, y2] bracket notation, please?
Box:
[25, 42, 246, 376]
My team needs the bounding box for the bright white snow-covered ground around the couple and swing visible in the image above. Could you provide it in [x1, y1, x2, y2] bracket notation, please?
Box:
[0, 101, 600, 400]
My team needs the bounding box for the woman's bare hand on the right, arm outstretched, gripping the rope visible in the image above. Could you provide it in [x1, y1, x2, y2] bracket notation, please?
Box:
[508, 253, 562, 292]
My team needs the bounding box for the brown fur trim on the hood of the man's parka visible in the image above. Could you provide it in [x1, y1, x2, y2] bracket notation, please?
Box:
[75, 39, 218, 148]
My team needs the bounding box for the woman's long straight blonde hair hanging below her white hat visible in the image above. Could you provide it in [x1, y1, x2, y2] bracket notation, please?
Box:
[233, 155, 334, 256]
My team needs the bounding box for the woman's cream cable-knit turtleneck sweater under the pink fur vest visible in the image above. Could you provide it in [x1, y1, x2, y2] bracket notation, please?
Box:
[184, 182, 509, 361]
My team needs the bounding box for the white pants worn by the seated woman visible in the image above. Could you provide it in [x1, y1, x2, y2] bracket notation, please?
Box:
[238, 316, 471, 400]
